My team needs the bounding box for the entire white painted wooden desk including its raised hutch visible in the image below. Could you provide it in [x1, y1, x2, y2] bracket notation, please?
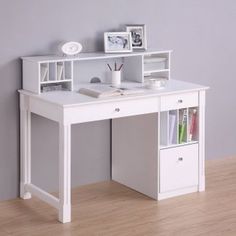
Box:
[20, 51, 207, 223]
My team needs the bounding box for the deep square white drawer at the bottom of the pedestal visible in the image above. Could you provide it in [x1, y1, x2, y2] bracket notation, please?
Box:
[160, 144, 198, 192]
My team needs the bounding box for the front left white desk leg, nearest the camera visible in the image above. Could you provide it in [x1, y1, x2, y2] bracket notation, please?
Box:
[59, 124, 71, 223]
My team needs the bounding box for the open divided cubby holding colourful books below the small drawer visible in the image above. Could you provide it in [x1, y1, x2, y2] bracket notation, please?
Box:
[160, 107, 199, 148]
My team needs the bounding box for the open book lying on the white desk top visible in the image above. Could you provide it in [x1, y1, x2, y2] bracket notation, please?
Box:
[78, 84, 144, 98]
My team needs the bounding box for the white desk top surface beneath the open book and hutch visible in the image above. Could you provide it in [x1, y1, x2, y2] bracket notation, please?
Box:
[19, 80, 208, 107]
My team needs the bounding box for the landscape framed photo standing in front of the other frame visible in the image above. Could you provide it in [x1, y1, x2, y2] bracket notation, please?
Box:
[104, 32, 132, 53]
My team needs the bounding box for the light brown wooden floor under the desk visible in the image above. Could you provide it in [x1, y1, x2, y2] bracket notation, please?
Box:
[0, 158, 236, 236]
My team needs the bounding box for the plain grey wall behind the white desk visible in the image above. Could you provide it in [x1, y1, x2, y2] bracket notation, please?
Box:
[0, 0, 236, 200]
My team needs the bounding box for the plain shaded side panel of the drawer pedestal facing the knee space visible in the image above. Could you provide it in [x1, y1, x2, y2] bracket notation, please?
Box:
[112, 113, 158, 199]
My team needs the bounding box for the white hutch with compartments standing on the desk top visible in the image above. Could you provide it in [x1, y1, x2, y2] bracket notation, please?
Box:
[23, 51, 171, 94]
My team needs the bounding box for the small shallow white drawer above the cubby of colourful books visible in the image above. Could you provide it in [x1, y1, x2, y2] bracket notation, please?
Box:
[161, 92, 198, 111]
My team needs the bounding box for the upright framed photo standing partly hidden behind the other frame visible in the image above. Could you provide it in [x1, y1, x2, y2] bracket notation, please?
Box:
[126, 25, 147, 50]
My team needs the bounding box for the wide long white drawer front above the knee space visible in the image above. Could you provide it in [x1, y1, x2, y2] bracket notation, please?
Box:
[65, 97, 159, 124]
